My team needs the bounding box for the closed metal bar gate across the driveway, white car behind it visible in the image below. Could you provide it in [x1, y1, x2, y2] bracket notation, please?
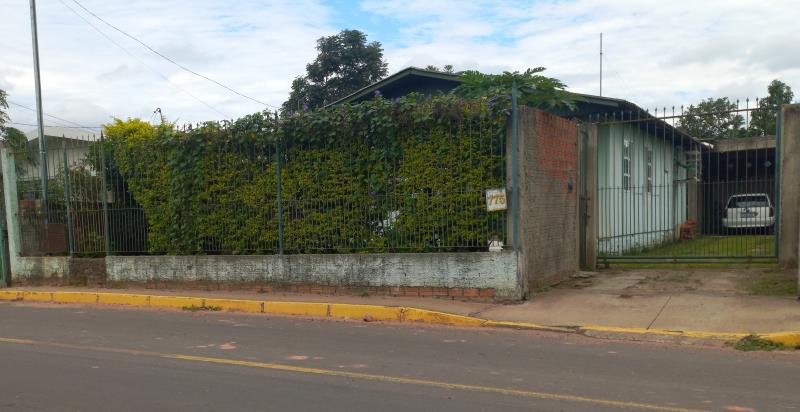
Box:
[593, 102, 780, 265]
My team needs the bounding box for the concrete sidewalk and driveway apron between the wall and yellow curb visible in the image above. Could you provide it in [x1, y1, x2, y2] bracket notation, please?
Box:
[11, 270, 800, 333]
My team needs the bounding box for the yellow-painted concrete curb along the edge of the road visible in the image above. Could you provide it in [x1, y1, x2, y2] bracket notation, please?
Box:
[0, 290, 800, 347]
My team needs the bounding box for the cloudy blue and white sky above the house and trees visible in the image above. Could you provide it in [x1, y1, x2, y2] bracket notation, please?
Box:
[0, 0, 800, 131]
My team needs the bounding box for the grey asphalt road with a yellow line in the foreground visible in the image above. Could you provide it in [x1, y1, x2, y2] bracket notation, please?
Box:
[0, 303, 800, 412]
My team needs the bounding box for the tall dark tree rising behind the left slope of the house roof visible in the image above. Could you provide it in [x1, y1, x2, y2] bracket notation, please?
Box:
[282, 30, 387, 114]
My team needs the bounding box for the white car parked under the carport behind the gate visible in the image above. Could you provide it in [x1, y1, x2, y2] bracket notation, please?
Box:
[722, 193, 775, 230]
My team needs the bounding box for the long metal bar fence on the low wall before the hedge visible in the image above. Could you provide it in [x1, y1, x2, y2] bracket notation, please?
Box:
[9, 102, 506, 256]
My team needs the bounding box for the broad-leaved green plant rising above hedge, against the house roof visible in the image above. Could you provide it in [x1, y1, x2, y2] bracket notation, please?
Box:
[452, 67, 574, 110]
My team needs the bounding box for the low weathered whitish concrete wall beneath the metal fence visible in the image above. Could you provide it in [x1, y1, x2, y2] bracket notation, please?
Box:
[13, 251, 522, 300]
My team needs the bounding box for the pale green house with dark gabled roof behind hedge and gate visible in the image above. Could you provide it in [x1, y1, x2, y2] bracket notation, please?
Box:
[329, 67, 704, 255]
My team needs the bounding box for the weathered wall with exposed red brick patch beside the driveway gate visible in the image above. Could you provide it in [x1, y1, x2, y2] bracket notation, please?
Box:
[519, 108, 580, 291]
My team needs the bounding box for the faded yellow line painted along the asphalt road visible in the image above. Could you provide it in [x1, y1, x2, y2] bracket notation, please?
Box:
[0, 337, 706, 412]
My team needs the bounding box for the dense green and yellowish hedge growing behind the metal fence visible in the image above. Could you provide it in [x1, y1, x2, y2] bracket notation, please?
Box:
[105, 96, 508, 254]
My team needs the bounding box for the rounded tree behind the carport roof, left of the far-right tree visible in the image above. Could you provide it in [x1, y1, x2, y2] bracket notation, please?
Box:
[677, 97, 747, 139]
